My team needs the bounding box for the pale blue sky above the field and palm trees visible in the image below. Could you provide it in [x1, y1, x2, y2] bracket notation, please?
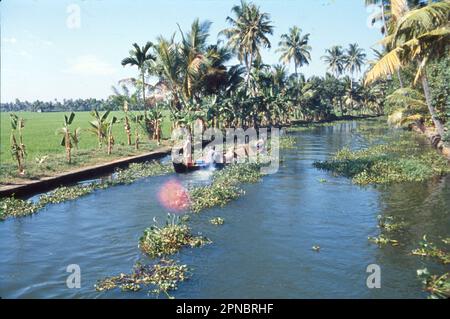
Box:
[0, 0, 380, 102]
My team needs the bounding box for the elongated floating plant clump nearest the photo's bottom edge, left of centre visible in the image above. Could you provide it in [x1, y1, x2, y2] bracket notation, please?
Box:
[95, 259, 189, 298]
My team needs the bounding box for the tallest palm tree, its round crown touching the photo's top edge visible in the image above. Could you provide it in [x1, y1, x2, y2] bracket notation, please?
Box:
[220, 0, 273, 91]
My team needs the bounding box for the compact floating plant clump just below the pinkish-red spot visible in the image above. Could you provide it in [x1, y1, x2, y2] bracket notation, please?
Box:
[139, 214, 211, 258]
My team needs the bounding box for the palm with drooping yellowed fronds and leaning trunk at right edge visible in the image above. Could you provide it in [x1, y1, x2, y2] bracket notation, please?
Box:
[365, 0, 450, 136]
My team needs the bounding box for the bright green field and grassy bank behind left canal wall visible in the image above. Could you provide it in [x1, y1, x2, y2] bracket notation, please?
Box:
[0, 111, 170, 184]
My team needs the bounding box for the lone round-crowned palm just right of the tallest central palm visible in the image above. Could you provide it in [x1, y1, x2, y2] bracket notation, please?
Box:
[277, 26, 311, 76]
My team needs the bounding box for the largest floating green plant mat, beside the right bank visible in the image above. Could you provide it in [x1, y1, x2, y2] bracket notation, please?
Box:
[314, 137, 450, 185]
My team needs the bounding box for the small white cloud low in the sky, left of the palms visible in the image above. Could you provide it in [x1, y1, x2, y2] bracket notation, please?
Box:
[63, 55, 116, 76]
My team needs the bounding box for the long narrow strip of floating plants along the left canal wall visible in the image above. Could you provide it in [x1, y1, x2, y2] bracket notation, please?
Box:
[0, 161, 173, 220]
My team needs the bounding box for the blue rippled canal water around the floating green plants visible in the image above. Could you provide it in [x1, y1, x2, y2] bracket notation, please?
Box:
[0, 122, 450, 298]
